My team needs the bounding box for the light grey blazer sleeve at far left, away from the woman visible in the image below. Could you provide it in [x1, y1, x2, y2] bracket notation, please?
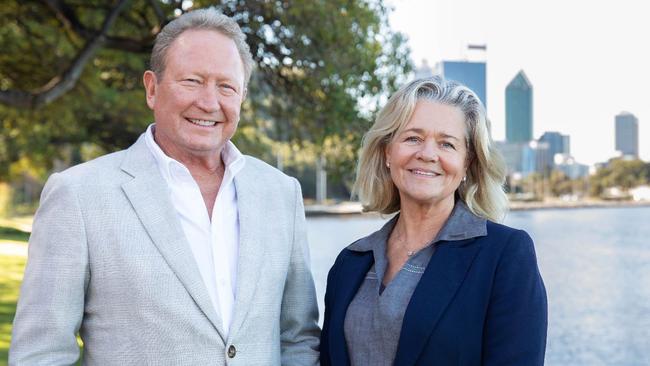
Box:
[9, 174, 90, 365]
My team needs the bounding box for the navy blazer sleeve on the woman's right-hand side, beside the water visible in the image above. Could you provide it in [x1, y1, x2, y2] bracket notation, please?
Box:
[483, 230, 547, 366]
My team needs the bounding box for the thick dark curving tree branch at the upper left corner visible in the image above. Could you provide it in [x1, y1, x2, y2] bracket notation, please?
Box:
[0, 0, 130, 108]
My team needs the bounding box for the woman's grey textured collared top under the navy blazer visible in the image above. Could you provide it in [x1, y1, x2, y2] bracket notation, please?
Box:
[344, 201, 487, 366]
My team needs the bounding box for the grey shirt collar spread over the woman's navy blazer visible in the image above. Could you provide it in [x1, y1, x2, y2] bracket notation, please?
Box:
[348, 200, 487, 252]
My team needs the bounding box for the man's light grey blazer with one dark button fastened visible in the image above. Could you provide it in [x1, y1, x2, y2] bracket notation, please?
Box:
[9, 136, 319, 366]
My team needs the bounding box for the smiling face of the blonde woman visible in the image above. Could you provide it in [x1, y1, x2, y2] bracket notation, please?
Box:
[385, 100, 467, 210]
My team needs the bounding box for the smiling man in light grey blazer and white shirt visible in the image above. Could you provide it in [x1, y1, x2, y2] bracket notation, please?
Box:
[9, 9, 319, 365]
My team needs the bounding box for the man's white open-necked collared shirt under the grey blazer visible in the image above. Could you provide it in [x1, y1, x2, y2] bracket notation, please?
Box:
[145, 124, 246, 337]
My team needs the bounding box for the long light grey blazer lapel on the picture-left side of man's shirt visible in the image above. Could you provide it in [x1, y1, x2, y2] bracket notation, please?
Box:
[122, 135, 225, 343]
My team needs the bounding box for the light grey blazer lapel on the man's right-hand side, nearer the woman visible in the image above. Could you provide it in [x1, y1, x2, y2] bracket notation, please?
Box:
[224, 167, 266, 334]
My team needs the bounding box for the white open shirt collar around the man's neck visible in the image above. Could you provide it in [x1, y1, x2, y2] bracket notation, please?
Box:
[145, 123, 246, 182]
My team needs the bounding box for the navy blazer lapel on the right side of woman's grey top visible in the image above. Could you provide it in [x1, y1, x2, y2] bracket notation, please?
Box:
[394, 239, 480, 365]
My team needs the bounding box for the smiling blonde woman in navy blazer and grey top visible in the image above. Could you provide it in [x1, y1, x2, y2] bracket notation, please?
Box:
[321, 77, 547, 366]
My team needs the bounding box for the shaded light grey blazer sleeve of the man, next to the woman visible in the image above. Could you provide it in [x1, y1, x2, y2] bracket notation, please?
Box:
[280, 179, 320, 366]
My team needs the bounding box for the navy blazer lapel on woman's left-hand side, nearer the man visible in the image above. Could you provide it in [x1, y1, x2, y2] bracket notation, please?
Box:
[329, 251, 374, 365]
